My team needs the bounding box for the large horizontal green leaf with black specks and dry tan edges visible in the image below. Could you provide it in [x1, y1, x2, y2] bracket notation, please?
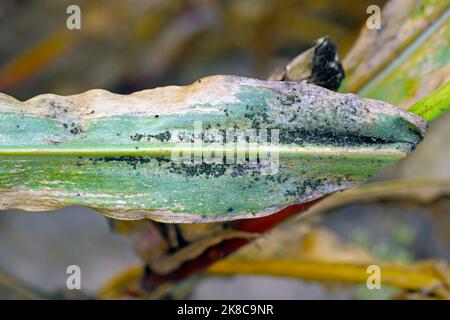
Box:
[0, 76, 427, 223]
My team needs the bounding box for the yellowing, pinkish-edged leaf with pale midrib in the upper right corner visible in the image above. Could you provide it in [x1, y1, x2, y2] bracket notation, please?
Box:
[340, 0, 450, 108]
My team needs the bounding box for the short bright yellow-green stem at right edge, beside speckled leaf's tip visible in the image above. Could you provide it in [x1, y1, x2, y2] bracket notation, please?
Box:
[408, 82, 450, 121]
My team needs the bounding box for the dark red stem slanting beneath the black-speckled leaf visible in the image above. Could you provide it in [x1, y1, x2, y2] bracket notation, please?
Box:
[143, 197, 323, 289]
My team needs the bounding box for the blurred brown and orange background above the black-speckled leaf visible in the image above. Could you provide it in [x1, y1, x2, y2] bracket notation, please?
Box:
[0, 0, 384, 99]
